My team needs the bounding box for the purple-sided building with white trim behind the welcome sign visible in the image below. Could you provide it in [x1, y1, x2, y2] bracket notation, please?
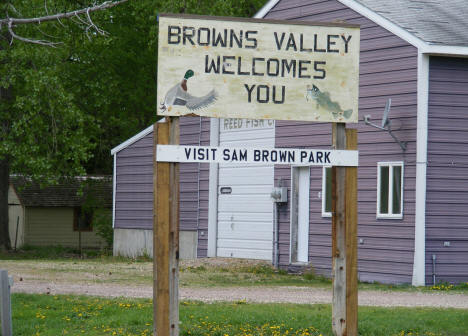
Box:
[112, 0, 468, 285]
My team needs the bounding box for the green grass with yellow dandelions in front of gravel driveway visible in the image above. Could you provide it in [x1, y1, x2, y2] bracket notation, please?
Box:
[12, 294, 468, 336]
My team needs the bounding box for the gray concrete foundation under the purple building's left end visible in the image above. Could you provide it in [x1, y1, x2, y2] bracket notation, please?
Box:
[113, 229, 197, 259]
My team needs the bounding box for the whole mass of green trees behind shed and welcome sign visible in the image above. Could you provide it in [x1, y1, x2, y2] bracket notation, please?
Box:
[0, 0, 265, 248]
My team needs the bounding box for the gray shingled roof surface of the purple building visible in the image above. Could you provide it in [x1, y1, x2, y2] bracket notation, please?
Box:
[355, 0, 468, 46]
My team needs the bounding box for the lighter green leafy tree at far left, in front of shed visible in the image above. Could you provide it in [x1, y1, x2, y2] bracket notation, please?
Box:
[0, 0, 128, 249]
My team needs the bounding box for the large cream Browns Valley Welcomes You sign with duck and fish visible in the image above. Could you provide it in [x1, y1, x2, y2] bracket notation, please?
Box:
[157, 15, 360, 123]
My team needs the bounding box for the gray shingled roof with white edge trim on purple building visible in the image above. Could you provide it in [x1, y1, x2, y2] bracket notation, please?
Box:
[255, 0, 468, 56]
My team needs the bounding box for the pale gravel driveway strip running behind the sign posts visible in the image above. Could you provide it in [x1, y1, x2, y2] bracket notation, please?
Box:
[12, 281, 468, 309]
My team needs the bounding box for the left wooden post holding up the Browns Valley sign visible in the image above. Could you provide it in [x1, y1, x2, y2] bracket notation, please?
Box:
[153, 117, 179, 336]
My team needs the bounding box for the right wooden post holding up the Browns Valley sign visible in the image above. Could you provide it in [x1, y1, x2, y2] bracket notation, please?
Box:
[332, 123, 358, 336]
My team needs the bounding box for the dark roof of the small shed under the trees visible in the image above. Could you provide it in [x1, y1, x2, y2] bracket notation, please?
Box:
[10, 176, 112, 208]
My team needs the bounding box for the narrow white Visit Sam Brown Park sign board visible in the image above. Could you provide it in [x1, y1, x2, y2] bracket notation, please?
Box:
[156, 145, 359, 167]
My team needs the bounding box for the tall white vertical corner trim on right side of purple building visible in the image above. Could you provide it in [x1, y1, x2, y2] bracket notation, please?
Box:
[412, 50, 429, 286]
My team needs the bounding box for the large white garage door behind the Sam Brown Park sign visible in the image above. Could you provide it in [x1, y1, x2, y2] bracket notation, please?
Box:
[217, 119, 275, 260]
